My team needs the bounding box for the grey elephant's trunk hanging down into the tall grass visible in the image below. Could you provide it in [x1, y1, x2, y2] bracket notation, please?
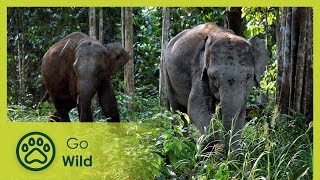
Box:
[221, 91, 246, 147]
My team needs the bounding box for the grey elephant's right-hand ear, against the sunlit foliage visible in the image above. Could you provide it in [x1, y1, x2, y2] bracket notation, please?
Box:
[249, 36, 269, 83]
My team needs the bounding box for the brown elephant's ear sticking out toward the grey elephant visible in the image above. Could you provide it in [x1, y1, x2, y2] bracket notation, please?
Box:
[106, 42, 132, 75]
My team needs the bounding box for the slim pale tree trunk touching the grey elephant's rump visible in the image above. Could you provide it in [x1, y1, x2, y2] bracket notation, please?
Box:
[159, 7, 170, 108]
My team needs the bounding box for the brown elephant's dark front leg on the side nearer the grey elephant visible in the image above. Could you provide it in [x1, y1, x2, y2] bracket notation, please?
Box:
[98, 80, 120, 122]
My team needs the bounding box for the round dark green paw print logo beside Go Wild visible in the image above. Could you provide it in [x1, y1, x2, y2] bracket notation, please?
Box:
[16, 132, 56, 171]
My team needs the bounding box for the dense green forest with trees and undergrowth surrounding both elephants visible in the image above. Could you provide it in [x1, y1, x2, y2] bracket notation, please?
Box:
[7, 7, 313, 179]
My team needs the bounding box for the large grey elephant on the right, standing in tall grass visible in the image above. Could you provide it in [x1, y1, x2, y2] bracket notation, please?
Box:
[163, 23, 269, 147]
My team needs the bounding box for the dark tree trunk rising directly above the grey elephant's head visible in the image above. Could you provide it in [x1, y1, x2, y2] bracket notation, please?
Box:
[225, 7, 242, 36]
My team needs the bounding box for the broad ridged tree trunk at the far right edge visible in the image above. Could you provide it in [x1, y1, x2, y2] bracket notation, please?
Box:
[277, 7, 313, 121]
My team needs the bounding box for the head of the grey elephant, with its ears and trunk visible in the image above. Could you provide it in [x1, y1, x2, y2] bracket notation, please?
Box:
[201, 31, 268, 145]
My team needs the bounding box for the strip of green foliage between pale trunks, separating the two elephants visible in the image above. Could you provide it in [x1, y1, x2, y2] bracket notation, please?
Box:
[133, 7, 162, 98]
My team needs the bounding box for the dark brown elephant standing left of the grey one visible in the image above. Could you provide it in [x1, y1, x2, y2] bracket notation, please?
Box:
[41, 32, 131, 122]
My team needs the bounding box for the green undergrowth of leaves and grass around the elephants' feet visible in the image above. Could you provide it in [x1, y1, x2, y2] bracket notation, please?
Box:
[8, 93, 313, 180]
